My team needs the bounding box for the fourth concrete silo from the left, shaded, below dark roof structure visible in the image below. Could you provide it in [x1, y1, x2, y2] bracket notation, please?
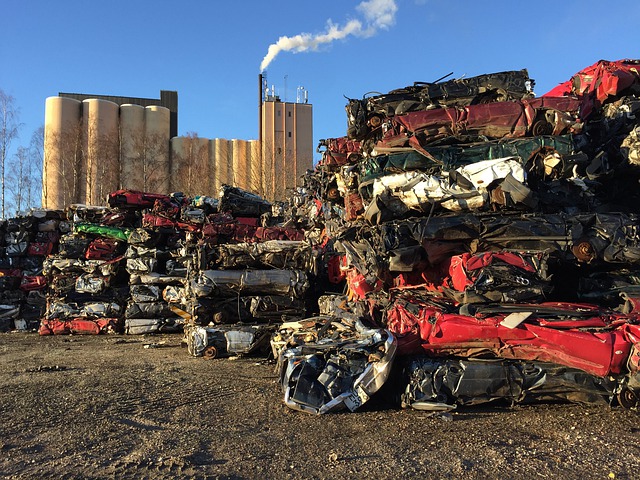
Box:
[141, 105, 171, 193]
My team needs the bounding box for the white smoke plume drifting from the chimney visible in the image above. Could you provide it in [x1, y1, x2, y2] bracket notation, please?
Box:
[260, 0, 398, 72]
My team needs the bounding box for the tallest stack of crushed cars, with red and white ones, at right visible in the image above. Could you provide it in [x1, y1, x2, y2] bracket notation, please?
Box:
[294, 60, 640, 412]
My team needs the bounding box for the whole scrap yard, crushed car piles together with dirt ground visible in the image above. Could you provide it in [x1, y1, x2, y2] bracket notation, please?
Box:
[0, 59, 640, 479]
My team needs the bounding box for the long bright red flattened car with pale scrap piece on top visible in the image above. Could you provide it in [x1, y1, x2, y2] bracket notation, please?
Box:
[385, 296, 640, 377]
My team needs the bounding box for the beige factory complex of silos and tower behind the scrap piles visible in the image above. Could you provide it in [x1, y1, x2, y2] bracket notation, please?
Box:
[42, 83, 313, 209]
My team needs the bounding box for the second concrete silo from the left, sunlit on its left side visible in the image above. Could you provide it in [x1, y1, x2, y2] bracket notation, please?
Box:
[81, 98, 120, 205]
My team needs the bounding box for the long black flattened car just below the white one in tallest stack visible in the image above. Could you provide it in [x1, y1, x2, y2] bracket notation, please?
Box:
[374, 213, 640, 265]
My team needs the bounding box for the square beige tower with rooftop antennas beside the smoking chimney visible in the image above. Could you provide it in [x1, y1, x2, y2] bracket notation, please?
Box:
[257, 75, 313, 200]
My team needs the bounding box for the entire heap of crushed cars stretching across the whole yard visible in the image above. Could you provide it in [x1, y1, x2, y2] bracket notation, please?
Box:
[0, 60, 640, 413]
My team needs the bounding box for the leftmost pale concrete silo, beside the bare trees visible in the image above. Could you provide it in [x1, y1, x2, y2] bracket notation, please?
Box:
[42, 97, 82, 209]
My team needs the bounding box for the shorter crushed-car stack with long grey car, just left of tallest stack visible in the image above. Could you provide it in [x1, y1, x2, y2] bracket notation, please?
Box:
[185, 185, 316, 358]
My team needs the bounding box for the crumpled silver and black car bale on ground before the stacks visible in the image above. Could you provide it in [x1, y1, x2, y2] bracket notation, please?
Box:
[278, 318, 396, 414]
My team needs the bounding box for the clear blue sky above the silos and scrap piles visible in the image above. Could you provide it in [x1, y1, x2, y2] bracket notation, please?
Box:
[0, 0, 640, 163]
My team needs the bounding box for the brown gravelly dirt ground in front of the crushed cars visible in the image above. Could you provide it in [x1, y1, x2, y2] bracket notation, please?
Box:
[0, 333, 640, 479]
